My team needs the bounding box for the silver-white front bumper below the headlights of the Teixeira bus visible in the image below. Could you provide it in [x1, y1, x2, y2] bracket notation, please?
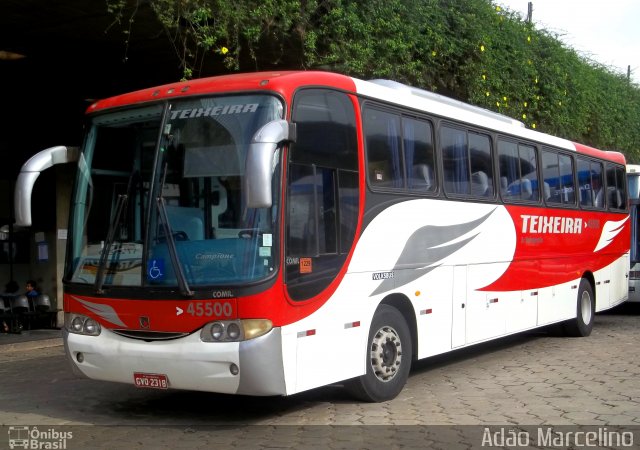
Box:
[63, 328, 287, 395]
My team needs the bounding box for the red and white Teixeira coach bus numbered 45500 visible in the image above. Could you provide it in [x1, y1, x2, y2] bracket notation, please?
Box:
[16, 72, 630, 401]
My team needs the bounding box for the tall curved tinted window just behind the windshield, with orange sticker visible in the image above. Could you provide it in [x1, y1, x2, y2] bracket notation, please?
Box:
[286, 89, 359, 300]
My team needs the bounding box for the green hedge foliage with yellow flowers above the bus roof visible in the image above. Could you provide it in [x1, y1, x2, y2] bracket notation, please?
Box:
[106, 0, 640, 162]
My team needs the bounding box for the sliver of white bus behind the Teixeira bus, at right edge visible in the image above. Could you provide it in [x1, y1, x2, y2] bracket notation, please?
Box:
[627, 164, 640, 302]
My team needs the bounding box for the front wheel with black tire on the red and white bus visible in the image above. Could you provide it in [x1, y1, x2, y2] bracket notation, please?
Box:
[345, 305, 413, 402]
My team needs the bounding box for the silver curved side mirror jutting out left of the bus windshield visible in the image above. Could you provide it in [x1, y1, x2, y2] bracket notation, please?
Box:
[13, 146, 79, 227]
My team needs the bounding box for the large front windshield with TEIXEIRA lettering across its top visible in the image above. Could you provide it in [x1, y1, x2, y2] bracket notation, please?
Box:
[66, 95, 283, 291]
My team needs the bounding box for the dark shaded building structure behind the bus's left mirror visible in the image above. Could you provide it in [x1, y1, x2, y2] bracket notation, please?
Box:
[0, 0, 181, 323]
